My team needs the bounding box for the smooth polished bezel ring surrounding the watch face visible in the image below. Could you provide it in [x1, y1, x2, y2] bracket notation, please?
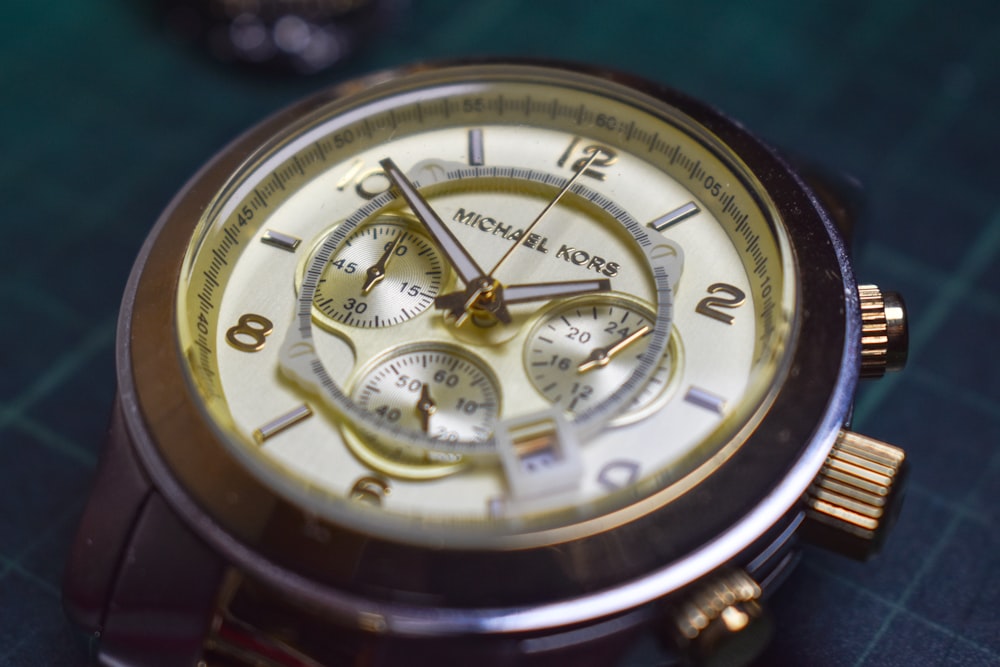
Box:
[118, 61, 858, 634]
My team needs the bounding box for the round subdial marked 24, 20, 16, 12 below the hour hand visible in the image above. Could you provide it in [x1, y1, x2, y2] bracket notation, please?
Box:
[524, 299, 665, 413]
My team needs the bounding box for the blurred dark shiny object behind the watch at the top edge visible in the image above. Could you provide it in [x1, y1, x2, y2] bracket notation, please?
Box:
[156, 0, 409, 74]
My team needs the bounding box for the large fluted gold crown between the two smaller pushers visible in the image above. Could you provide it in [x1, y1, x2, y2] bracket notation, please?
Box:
[801, 430, 906, 560]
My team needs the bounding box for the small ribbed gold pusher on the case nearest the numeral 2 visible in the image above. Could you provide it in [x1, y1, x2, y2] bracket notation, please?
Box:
[858, 285, 909, 378]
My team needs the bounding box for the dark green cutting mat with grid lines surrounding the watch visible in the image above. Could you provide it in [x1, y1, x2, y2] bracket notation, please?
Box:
[0, 0, 1000, 667]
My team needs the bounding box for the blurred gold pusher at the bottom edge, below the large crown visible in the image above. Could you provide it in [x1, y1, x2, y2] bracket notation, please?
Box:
[669, 569, 772, 667]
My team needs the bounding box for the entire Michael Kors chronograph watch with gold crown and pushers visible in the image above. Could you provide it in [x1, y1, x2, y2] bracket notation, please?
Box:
[65, 61, 906, 666]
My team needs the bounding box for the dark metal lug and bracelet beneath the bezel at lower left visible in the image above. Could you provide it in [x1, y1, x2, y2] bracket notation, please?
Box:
[64, 398, 644, 667]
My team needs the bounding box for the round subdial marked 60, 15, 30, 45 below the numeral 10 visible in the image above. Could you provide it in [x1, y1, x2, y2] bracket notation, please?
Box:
[313, 216, 444, 328]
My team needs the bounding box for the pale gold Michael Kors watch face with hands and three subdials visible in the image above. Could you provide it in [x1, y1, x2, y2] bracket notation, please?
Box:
[176, 65, 796, 546]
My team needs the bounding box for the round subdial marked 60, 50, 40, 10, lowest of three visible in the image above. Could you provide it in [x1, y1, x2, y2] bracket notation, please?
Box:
[353, 345, 500, 442]
